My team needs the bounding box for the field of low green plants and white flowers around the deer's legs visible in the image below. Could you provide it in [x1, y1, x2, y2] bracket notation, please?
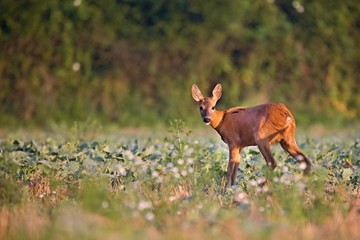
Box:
[0, 120, 360, 239]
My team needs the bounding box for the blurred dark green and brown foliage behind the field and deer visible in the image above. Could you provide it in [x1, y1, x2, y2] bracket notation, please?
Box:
[0, 0, 360, 127]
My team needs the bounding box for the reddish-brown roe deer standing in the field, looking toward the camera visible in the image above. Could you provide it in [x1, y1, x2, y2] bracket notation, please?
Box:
[191, 84, 311, 186]
